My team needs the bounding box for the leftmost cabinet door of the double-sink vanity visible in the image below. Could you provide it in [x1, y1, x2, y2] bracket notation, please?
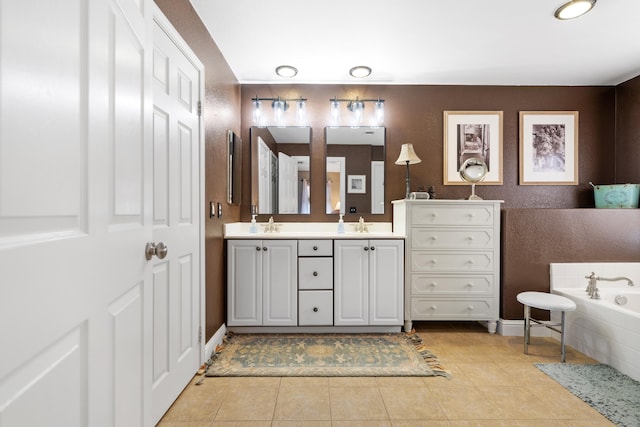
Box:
[227, 240, 262, 326]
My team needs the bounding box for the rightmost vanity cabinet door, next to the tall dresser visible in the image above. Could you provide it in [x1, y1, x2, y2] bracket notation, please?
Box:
[369, 240, 404, 325]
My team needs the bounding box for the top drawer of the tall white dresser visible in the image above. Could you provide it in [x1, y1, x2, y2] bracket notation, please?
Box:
[411, 203, 493, 226]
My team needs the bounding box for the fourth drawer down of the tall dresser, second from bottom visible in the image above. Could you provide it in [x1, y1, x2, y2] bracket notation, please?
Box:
[411, 274, 493, 297]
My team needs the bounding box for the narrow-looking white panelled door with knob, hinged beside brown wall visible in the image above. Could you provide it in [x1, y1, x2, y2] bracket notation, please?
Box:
[150, 8, 204, 423]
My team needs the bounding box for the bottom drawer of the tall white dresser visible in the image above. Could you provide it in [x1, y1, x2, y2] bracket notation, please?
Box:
[411, 298, 494, 320]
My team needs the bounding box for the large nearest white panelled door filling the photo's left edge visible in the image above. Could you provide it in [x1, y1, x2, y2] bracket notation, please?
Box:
[0, 0, 152, 427]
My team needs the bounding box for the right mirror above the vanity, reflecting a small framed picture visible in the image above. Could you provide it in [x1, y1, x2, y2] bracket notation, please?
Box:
[325, 126, 386, 214]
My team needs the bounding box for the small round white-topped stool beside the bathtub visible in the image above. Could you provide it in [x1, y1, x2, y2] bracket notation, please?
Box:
[516, 291, 576, 363]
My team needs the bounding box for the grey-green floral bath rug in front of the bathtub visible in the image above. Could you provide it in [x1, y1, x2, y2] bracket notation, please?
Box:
[535, 363, 640, 427]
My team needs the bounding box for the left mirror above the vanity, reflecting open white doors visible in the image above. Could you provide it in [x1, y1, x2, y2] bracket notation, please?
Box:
[251, 126, 311, 214]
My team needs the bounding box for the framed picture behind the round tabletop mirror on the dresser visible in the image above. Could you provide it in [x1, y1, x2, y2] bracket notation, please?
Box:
[443, 111, 502, 185]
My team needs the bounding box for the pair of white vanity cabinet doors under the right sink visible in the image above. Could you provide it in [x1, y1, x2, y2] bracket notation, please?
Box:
[334, 239, 404, 326]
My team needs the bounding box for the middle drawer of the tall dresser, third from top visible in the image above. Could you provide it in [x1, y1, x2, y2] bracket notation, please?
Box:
[410, 251, 494, 273]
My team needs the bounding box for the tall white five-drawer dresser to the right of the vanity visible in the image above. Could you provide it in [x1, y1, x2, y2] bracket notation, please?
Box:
[393, 200, 502, 333]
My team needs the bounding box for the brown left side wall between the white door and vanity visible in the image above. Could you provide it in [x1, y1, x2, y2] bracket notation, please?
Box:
[155, 0, 241, 340]
